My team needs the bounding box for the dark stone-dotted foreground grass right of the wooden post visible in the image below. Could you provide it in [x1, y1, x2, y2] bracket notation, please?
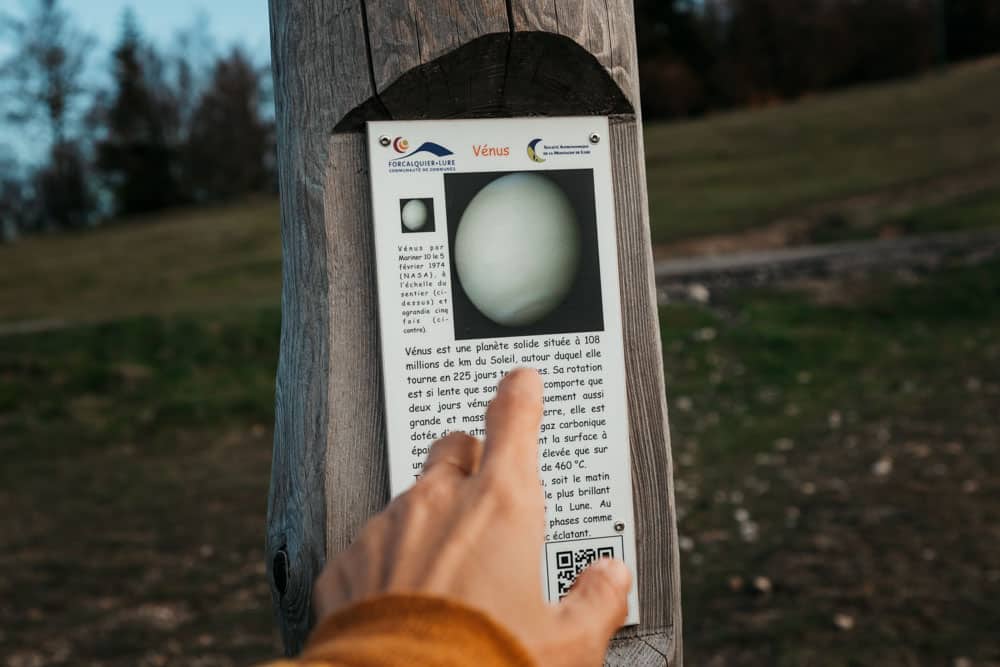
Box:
[661, 263, 1000, 666]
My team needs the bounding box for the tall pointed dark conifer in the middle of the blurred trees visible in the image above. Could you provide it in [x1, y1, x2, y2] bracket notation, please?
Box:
[91, 11, 181, 215]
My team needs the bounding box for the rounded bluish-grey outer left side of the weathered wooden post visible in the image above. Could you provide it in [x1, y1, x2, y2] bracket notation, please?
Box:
[266, 0, 373, 653]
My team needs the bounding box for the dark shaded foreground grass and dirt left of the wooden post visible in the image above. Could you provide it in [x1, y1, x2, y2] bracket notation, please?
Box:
[0, 308, 278, 665]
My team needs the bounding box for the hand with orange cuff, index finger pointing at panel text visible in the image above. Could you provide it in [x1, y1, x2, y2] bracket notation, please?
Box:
[262, 369, 631, 666]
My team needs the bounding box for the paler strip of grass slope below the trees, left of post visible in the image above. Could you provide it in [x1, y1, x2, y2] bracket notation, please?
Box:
[0, 199, 281, 323]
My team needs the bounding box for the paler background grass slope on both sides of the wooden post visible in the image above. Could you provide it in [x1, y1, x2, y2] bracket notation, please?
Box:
[0, 59, 1000, 323]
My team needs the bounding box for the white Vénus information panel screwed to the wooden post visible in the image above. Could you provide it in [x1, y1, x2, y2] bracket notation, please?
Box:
[368, 117, 639, 624]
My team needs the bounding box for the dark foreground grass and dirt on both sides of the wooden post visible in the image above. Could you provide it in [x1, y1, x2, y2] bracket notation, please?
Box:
[0, 263, 1000, 667]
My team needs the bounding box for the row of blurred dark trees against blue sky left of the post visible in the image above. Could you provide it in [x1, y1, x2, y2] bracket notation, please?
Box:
[0, 0, 275, 240]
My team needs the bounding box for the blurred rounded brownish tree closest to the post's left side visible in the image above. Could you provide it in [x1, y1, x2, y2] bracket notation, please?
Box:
[184, 48, 274, 201]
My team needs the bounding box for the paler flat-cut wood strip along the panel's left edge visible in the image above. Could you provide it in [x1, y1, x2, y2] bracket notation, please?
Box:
[317, 134, 389, 556]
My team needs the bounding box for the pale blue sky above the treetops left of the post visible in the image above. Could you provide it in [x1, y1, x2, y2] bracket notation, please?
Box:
[0, 0, 272, 162]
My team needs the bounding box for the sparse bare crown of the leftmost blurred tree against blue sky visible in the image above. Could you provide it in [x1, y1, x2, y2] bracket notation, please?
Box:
[0, 0, 93, 145]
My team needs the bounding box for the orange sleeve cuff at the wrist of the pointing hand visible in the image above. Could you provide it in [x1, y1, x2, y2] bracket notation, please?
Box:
[262, 595, 537, 667]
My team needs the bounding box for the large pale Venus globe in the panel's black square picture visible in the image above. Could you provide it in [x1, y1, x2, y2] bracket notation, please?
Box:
[454, 173, 580, 326]
